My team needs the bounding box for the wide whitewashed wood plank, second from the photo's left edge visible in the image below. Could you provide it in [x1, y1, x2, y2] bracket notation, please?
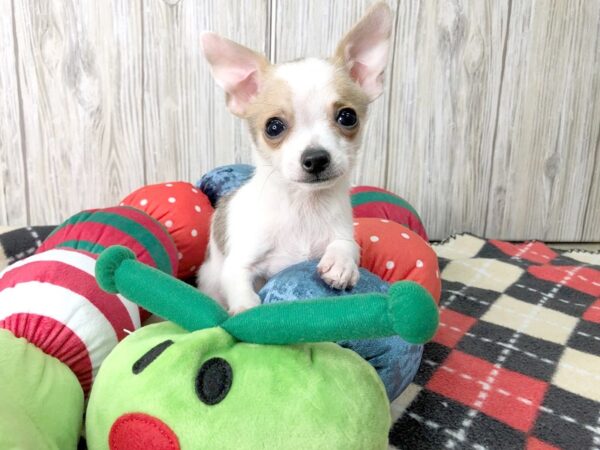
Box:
[15, 0, 143, 224]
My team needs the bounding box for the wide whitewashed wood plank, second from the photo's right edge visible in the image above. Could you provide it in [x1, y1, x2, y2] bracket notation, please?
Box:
[387, 0, 509, 239]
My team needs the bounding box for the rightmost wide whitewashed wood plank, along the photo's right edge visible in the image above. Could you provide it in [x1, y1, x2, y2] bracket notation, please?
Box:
[486, 0, 600, 241]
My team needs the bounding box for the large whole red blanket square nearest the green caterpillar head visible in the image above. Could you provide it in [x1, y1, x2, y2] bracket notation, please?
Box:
[427, 350, 548, 432]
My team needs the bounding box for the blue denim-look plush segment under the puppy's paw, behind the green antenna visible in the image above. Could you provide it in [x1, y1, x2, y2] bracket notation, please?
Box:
[258, 261, 423, 401]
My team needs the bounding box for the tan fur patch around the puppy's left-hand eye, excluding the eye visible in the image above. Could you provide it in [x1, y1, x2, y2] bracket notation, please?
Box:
[246, 67, 294, 150]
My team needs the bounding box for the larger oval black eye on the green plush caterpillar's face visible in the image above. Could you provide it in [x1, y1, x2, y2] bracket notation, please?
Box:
[196, 358, 233, 405]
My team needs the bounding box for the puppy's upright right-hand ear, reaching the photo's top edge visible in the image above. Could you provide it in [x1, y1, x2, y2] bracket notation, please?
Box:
[335, 2, 392, 101]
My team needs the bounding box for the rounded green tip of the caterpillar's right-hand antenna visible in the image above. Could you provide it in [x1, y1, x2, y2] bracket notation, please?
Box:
[388, 281, 439, 344]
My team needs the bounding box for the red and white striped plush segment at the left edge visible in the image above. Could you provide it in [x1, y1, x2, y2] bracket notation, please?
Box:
[0, 249, 140, 392]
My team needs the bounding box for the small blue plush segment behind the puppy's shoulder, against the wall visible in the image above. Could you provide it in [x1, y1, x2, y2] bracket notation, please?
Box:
[196, 164, 254, 207]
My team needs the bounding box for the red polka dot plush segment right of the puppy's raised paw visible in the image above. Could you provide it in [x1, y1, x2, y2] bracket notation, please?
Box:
[354, 218, 441, 302]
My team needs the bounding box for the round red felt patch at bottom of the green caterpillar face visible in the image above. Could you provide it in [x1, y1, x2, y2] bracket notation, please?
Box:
[108, 413, 180, 450]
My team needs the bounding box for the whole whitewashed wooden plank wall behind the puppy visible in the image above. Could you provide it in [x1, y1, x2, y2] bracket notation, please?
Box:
[0, 0, 600, 241]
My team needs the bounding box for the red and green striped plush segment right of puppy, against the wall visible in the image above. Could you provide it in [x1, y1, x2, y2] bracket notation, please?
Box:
[351, 186, 429, 241]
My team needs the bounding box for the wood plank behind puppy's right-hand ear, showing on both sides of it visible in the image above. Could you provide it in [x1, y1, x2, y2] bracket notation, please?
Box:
[271, 0, 397, 186]
